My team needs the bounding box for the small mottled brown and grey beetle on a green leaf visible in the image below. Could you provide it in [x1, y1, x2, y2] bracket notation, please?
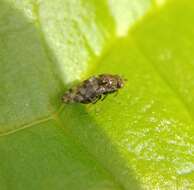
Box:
[62, 74, 124, 104]
